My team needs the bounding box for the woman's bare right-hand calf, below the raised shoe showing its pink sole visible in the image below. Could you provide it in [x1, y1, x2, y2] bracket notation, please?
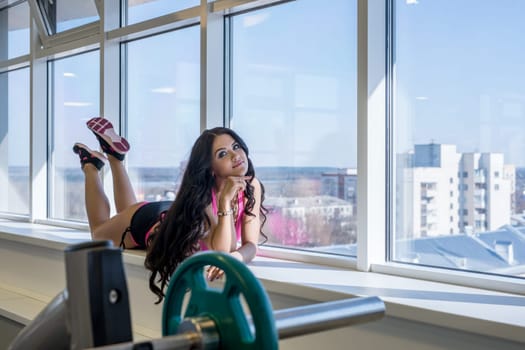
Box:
[107, 154, 137, 213]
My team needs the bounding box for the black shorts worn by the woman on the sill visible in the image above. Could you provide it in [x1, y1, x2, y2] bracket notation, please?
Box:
[121, 201, 173, 249]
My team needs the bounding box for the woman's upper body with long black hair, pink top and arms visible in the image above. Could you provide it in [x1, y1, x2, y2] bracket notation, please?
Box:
[145, 127, 266, 302]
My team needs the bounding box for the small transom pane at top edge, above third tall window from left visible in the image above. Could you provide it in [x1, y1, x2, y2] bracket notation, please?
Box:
[126, 0, 200, 24]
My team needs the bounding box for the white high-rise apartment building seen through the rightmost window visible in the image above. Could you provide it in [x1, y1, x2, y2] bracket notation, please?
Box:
[395, 143, 515, 239]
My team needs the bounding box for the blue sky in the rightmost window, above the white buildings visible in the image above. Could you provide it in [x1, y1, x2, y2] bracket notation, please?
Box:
[395, 0, 525, 166]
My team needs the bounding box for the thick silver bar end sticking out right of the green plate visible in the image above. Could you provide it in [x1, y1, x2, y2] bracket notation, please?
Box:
[274, 297, 385, 339]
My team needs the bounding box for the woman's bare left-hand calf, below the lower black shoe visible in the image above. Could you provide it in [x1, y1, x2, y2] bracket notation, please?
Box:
[82, 163, 110, 232]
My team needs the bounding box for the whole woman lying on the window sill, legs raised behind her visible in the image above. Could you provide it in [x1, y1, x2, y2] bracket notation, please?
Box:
[74, 118, 266, 303]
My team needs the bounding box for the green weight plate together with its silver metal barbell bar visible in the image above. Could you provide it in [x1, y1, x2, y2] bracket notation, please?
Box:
[86, 252, 385, 350]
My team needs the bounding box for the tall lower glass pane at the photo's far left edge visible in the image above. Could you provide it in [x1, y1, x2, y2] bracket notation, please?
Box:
[0, 68, 30, 215]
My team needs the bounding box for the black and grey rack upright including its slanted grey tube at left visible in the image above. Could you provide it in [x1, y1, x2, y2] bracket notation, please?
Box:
[9, 241, 132, 350]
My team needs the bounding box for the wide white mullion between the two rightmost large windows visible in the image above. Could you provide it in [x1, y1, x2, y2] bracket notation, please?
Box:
[357, 0, 386, 271]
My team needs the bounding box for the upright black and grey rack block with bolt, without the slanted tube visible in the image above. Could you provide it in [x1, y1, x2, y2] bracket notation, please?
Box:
[65, 241, 133, 350]
